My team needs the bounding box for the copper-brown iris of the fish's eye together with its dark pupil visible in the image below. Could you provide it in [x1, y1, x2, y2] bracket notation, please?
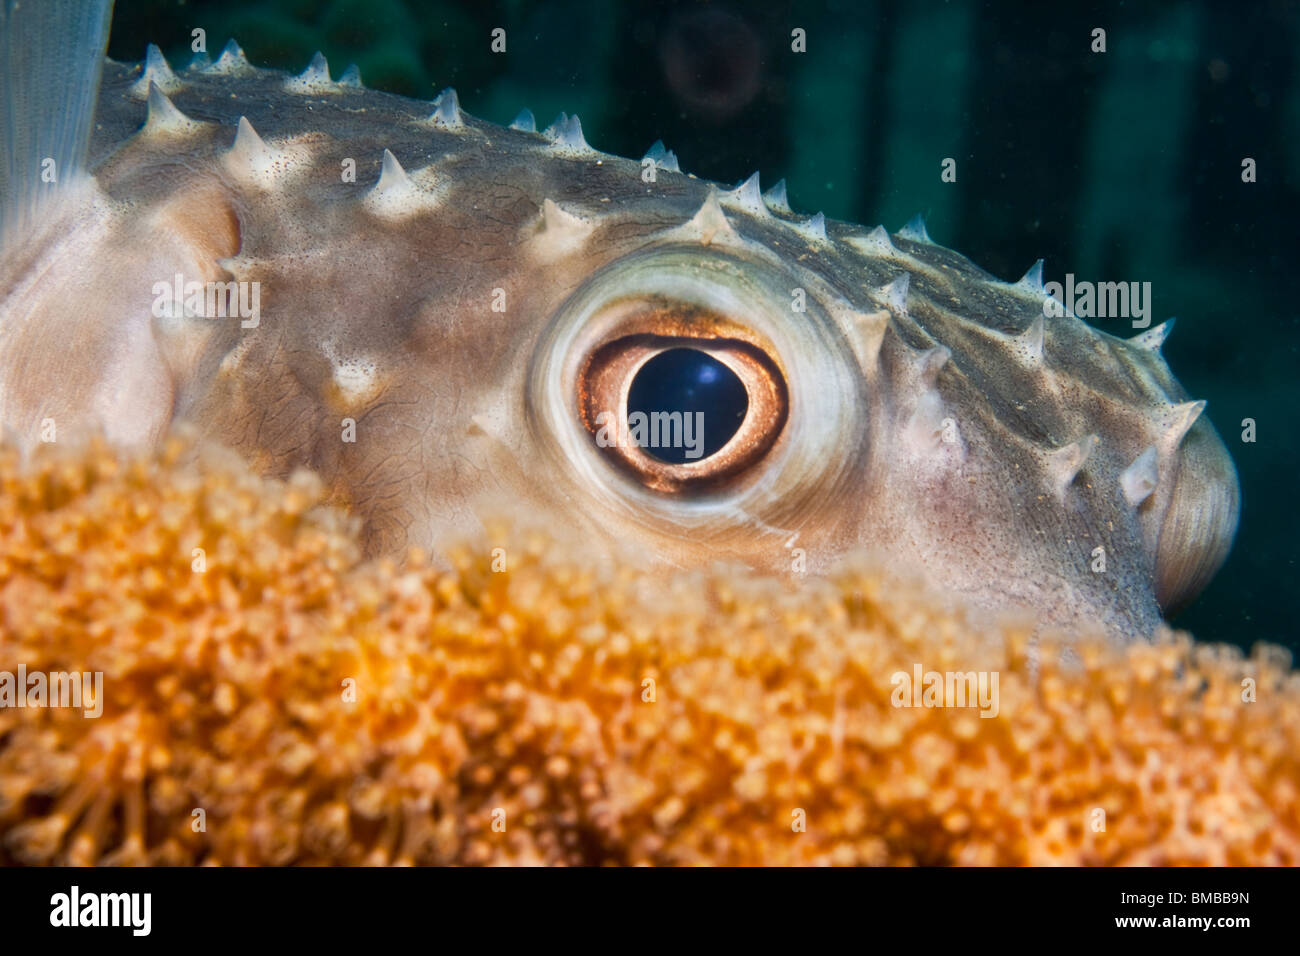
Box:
[579, 333, 788, 493]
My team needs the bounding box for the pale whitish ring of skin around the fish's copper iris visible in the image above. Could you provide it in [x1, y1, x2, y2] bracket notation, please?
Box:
[527, 245, 867, 532]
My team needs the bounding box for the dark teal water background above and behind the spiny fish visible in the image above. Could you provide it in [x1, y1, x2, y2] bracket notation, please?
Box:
[109, 0, 1300, 652]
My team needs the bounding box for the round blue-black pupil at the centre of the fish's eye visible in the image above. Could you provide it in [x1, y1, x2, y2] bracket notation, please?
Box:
[628, 349, 749, 464]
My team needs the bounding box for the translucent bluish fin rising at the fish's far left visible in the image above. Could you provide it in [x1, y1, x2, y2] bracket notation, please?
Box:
[0, 0, 113, 246]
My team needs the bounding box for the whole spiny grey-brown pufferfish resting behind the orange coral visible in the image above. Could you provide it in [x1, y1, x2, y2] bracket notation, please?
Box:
[0, 3, 1239, 640]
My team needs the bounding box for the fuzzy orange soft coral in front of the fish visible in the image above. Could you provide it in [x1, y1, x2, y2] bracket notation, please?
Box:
[0, 440, 1300, 865]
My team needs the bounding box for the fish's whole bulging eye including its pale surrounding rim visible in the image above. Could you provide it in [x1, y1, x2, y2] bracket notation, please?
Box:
[524, 243, 871, 522]
